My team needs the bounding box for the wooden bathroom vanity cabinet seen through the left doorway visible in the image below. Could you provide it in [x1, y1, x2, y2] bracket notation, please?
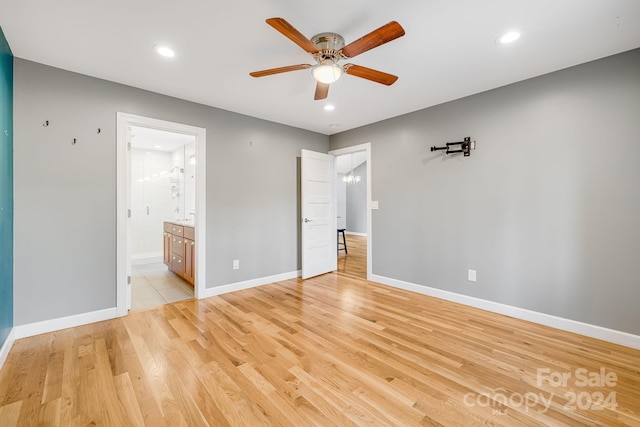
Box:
[163, 221, 196, 286]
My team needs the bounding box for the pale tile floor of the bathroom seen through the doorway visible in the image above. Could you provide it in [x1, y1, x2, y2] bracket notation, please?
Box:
[131, 262, 193, 311]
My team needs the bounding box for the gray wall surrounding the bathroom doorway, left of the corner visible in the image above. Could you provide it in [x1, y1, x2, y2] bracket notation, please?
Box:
[14, 59, 329, 325]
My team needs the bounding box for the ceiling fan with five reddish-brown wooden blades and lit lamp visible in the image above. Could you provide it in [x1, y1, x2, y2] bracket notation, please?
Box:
[249, 18, 404, 100]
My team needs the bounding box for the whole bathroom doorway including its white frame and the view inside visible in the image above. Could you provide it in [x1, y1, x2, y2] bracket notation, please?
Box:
[117, 113, 206, 315]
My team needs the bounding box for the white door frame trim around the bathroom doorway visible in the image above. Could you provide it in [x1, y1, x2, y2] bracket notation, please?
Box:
[116, 112, 207, 316]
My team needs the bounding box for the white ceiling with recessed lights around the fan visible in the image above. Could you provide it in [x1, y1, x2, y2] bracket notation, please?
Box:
[0, 0, 640, 135]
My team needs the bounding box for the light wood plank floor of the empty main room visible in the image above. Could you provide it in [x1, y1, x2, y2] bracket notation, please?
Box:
[0, 273, 640, 427]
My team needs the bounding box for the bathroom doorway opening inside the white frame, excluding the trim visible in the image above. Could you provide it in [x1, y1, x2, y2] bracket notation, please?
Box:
[129, 126, 196, 311]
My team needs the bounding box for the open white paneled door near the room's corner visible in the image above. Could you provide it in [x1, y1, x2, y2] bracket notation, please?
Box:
[301, 150, 338, 279]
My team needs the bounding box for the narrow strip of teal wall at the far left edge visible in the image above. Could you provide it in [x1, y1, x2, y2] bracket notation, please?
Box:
[0, 28, 13, 347]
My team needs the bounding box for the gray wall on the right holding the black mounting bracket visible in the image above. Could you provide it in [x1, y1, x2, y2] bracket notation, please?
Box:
[331, 50, 640, 334]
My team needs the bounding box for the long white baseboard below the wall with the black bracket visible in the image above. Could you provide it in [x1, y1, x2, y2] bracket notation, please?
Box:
[370, 275, 640, 350]
